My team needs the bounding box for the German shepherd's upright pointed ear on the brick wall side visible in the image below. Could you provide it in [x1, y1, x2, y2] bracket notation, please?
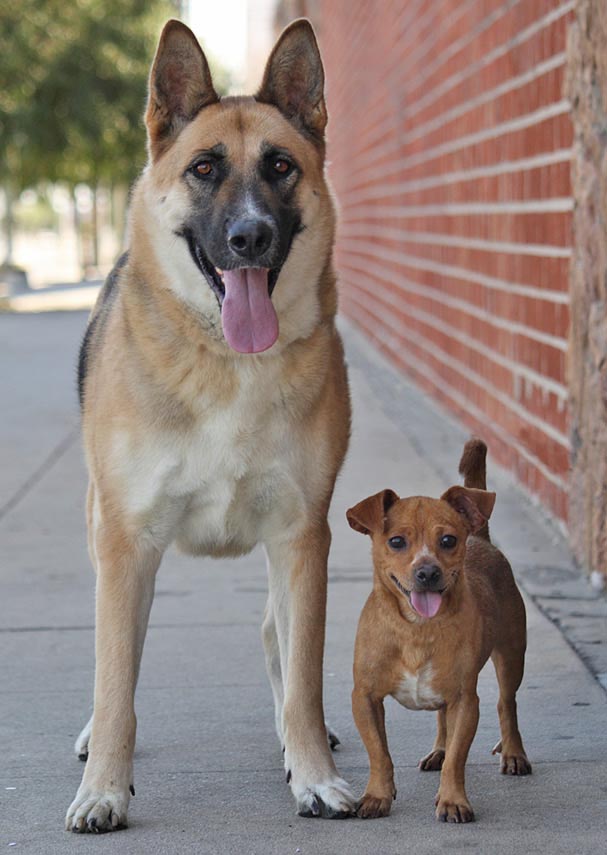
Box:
[255, 18, 327, 145]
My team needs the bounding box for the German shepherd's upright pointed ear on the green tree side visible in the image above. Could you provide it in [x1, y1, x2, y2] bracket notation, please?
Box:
[145, 21, 219, 160]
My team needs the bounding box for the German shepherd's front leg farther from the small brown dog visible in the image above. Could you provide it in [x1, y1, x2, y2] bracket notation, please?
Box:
[65, 519, 161, 833]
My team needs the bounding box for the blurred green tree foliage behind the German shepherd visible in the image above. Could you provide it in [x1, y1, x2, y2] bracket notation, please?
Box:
[0, 0, 175, 189]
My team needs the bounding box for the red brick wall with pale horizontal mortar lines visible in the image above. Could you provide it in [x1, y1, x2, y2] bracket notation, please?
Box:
[318, 0, 574, 520]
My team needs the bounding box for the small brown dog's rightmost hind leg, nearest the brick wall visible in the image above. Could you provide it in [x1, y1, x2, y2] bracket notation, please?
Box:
[491, 644, 531, 775]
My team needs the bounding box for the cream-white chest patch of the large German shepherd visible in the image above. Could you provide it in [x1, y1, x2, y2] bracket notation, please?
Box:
[113, 358, 322, 556]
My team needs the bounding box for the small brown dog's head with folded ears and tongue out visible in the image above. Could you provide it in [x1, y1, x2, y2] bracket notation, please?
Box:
[346, 487, 495, 619]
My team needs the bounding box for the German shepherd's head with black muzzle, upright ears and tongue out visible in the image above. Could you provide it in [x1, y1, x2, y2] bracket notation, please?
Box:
[132, 20, 334, 353]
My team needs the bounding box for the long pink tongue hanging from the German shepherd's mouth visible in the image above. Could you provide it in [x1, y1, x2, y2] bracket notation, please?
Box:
[221, 267, 278, 353]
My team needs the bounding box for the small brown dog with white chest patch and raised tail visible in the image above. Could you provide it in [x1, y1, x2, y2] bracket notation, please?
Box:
[347, 439, 531, 822]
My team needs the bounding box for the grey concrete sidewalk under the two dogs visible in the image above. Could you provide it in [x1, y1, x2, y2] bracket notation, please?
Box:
[0, 312, 607, 855]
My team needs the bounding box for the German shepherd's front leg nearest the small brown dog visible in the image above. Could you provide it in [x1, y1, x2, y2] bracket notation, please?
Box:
[266, 522, 355, 819]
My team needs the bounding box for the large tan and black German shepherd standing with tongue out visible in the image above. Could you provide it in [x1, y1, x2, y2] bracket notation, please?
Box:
[66, 20, 355, 832]
